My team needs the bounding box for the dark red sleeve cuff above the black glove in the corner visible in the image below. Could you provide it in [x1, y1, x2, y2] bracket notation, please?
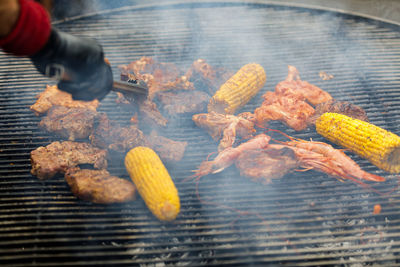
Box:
[0, 0, 51, 56]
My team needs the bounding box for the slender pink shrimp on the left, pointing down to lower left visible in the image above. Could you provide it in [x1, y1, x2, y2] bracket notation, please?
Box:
[193, 134, 271, 178]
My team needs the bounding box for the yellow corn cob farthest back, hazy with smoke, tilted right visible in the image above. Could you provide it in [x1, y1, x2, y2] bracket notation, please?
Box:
[208, 63, 267, 114]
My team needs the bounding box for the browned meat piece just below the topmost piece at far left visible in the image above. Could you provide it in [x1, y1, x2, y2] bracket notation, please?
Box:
[39, 106, 98, 141]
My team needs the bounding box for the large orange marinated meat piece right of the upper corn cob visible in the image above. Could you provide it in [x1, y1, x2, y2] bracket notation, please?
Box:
[254, 88, 315, 131]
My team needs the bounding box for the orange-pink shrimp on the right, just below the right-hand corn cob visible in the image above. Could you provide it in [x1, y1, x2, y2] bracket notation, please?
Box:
[285, 140, 385, 182]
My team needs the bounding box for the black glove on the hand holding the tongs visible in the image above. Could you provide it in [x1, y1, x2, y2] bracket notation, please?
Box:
[31, 28, 113, 101]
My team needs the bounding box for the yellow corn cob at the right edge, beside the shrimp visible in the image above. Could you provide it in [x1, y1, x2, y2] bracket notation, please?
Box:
[315, 113, 400, 173]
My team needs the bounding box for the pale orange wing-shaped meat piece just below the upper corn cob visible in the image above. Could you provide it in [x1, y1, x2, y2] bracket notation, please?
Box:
[192, 112, 256, 152]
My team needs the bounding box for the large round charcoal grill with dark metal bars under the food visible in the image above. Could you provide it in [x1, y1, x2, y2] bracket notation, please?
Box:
[0, 1, 400, 266]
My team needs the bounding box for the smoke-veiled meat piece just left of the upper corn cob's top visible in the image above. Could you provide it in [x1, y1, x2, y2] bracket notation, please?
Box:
[184, 59, 234, 95]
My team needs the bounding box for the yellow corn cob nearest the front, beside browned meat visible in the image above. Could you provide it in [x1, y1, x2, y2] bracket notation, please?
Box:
[125, 146, 180, 221]
